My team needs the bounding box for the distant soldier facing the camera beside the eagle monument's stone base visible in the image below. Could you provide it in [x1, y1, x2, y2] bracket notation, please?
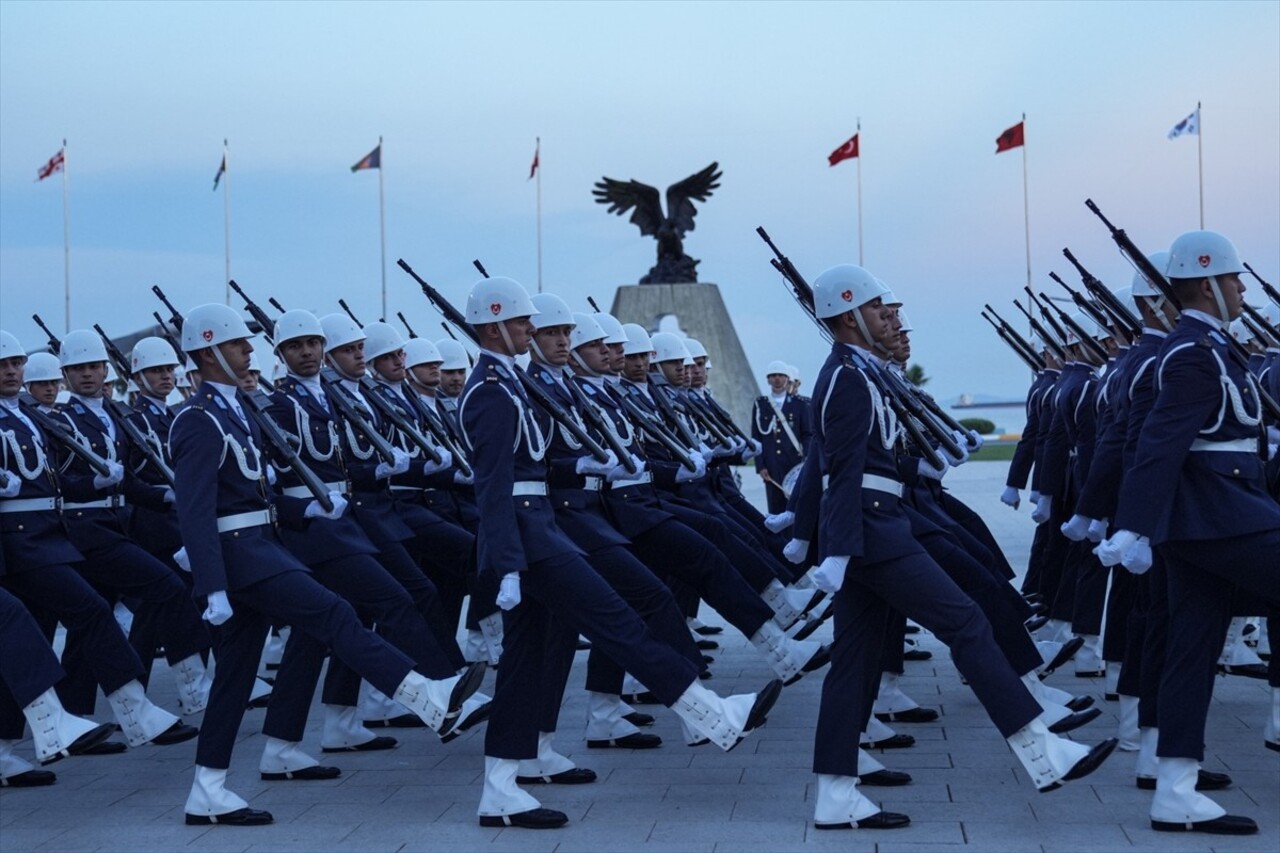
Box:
[751, 361, 810, 515]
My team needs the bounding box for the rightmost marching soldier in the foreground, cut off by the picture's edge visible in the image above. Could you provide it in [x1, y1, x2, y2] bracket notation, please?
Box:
[1098, 231, 1280, 835]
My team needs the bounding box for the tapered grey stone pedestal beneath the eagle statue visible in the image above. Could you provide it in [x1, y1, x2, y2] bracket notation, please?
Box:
[609, 283, 760, 434]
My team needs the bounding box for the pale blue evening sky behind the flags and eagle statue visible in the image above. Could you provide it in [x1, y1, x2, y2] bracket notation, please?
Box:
[0, 0, 1280, 412]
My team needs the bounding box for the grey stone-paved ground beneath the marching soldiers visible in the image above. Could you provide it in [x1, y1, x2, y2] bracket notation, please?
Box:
[0, 462, 1280, 853]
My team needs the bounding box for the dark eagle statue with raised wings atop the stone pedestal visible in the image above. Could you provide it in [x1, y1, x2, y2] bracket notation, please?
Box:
[591, 163, 721, 284]
